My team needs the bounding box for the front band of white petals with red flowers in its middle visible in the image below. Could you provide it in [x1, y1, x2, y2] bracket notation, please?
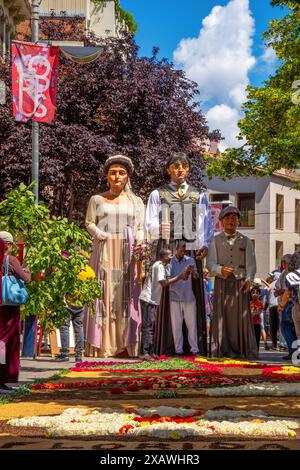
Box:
[8, 407, 300, 440]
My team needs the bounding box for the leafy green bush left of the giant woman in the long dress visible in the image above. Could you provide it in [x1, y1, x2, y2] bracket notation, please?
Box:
[0, 183, 101, 329]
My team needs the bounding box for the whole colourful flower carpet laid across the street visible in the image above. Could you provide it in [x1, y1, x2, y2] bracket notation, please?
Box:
[0, 357, 300, 448]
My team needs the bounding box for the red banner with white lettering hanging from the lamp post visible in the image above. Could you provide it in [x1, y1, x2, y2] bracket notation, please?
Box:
[12, 42, 59, 124]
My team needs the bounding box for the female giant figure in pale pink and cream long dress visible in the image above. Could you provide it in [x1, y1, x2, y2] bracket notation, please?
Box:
[85, 155, 144, 357]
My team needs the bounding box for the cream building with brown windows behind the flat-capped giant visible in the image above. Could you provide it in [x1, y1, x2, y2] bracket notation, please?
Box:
[206, 170, 300, 278]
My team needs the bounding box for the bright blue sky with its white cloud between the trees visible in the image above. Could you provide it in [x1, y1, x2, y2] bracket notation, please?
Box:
[121, 0, 286, 150]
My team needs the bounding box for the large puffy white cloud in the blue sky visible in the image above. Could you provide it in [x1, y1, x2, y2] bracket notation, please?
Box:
[174, 0, 256, 146]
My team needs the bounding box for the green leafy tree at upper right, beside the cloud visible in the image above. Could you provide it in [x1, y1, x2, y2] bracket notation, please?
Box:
[207, 0, 300, 178]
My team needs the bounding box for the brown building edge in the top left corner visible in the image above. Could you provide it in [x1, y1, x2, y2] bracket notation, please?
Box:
[0, 0, 31, 60]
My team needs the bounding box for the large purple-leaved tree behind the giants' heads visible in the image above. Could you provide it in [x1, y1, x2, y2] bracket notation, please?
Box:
[0, 21, 220, 223]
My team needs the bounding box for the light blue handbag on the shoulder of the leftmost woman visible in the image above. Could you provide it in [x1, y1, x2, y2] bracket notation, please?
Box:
[1, 256, 29, 306]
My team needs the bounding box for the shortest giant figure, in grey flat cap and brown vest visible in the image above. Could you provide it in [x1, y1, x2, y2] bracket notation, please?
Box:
[207, 206, 257, 359]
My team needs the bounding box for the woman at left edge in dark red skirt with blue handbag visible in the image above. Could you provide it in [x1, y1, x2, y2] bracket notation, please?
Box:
[0, 232, 31, 393]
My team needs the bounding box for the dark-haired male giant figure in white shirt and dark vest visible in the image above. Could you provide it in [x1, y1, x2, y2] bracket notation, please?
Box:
[145, 153, 214, 355]
